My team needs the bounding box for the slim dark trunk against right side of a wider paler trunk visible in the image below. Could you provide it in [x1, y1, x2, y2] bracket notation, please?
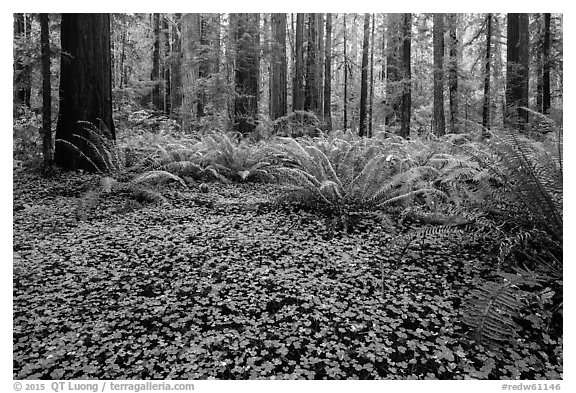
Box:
[400, 13, 412, 138]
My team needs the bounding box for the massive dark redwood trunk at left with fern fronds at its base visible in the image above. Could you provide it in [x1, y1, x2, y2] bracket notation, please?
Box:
[54, 14, 116, 170]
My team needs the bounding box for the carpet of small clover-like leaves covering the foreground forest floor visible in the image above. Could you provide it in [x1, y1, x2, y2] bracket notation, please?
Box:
[13, 169, 562, 379]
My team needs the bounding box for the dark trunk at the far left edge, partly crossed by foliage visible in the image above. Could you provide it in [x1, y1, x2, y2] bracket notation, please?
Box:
[14, 14, 32, 108]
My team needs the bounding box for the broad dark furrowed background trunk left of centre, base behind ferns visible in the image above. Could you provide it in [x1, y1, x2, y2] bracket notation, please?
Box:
[234, 14, 260, 135]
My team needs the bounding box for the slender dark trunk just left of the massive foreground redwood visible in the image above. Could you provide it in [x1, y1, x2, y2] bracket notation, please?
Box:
[40, 14, 54, 169]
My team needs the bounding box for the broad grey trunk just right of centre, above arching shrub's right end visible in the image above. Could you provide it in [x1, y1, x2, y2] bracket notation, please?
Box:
[304, 13, 321, 115]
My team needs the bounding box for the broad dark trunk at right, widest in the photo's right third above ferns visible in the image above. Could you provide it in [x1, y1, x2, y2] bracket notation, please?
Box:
[506, 14, 529, 130]
